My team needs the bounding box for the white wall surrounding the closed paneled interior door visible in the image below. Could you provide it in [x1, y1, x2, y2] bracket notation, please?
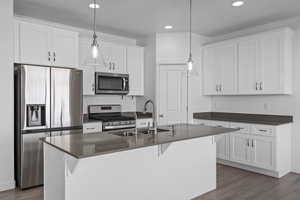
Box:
[137, 32, 211, 119]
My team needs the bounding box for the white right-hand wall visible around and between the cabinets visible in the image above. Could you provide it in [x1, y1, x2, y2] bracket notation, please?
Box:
[212, 18, 300, 173]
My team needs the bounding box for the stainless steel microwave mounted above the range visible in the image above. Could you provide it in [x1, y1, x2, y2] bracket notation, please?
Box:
[95, 72, 129, 95]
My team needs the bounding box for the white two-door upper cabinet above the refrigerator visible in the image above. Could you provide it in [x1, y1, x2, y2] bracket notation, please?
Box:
[15, 21, 78, 67]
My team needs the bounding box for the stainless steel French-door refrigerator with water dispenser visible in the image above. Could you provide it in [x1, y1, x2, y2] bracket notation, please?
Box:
[14, 64, 82, 189]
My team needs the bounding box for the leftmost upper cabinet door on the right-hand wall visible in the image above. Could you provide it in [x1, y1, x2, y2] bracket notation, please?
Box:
[203, 46, 221, 95]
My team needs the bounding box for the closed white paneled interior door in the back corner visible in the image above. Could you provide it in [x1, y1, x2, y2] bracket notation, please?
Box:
[158, 65, 187, 125]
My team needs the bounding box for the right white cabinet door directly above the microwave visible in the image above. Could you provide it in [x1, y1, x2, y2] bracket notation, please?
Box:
[110, 44, 126, 74]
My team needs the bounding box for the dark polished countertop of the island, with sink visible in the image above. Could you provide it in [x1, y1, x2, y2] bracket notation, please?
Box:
[42, 124, 238, 158]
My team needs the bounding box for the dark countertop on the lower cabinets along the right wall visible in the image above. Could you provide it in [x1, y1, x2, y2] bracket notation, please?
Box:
[194, 112, 293, 126]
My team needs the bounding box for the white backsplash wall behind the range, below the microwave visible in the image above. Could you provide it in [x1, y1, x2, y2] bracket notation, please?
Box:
[83, 95, 136, 113]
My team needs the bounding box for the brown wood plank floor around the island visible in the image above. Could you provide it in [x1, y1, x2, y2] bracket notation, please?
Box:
[0, 165, 300, 200]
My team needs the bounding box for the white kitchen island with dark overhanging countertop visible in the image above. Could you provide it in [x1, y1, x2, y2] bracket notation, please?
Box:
[43, 124, 238, 200]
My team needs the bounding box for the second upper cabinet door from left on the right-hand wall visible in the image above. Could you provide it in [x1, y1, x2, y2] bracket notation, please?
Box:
[216, 43, 237, 94]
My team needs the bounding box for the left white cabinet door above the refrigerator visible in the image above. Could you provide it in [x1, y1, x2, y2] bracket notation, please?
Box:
[19, 22, 52, 65]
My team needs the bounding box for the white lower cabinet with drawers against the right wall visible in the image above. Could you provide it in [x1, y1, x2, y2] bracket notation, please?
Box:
[194, 120, 291, 178]
